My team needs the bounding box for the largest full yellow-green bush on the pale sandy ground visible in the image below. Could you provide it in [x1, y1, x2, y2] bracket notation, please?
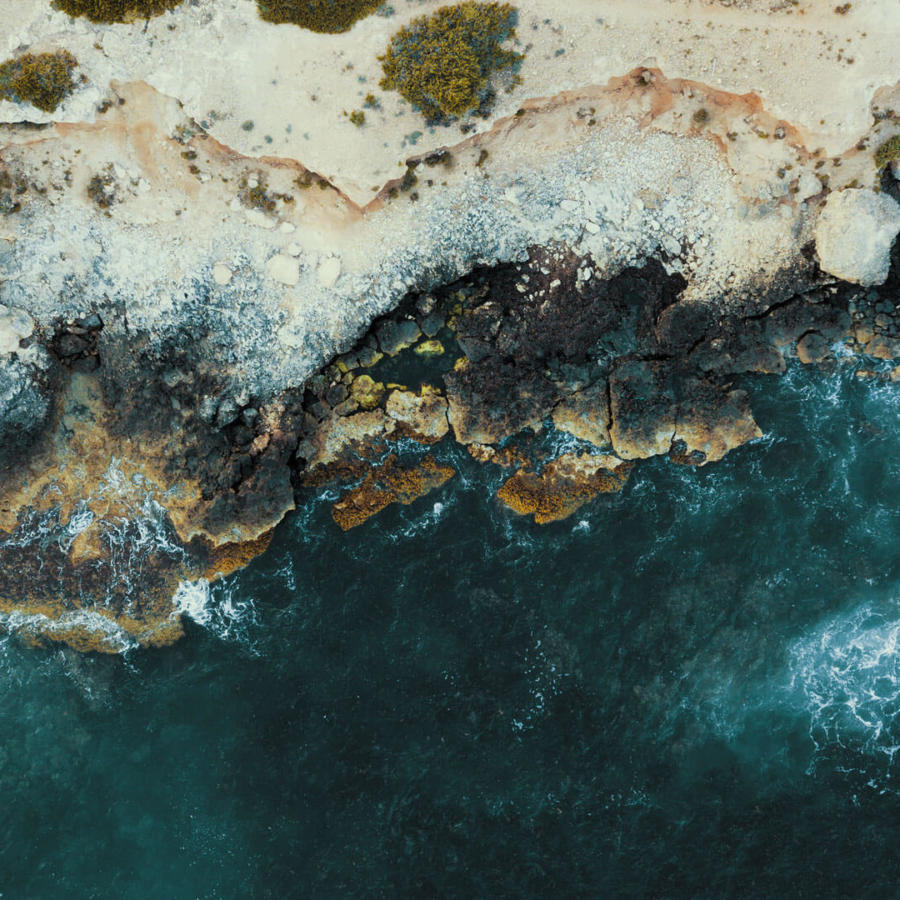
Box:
[380, 0, 524, 122]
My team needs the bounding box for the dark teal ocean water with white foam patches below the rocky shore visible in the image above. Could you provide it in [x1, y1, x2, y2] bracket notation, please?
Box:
[0, 367, 900, 900]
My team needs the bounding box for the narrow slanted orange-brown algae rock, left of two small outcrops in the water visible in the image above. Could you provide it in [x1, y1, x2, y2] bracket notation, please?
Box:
[331, 454, 456, 531]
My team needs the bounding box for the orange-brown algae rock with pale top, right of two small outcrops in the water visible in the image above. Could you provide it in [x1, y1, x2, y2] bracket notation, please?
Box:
[497, 453, 633, 525]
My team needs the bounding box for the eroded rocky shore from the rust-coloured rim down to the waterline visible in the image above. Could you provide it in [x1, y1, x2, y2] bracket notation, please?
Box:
[0, 69, 900, 650]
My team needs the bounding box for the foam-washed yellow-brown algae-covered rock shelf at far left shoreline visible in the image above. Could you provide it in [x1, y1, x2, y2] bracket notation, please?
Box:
[0, 372, 293, 653]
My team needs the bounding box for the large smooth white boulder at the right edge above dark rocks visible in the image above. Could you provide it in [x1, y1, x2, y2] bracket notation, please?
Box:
[816, 190, 900, 285]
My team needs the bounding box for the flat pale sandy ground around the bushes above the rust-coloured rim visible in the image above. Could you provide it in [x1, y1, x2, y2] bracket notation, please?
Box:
[0, 0, 900, 204]
